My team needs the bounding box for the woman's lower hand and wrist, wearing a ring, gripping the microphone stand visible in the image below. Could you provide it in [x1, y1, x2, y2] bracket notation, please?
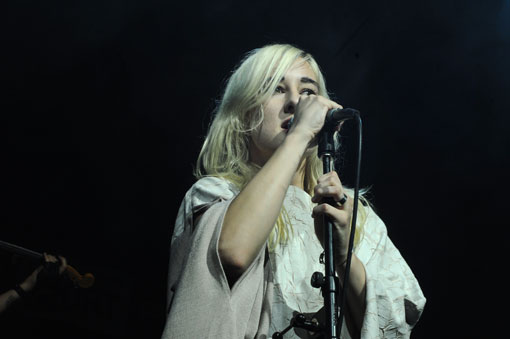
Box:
[312, 171, 353, 265]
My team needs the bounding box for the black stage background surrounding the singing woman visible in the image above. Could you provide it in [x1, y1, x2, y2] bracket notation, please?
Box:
[0, 0, 510, 338]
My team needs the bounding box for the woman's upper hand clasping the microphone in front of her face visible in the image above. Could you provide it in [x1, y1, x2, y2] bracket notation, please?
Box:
[289, 94, 342, 143]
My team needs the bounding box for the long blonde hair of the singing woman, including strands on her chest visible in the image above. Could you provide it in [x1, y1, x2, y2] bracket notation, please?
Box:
[194, 44, 365, 250]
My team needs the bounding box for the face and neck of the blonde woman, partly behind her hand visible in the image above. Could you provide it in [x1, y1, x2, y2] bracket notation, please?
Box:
[250, 59, 319, 166]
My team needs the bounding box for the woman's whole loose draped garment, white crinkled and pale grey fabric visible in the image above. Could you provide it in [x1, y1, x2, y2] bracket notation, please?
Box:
[163, 177, 425, 338]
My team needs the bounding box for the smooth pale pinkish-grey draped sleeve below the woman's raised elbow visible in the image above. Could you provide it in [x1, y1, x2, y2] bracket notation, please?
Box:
[162, 178, 273, 339]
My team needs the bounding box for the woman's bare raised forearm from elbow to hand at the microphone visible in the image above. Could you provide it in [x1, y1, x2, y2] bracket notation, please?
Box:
[218, 95, 339, 285]
